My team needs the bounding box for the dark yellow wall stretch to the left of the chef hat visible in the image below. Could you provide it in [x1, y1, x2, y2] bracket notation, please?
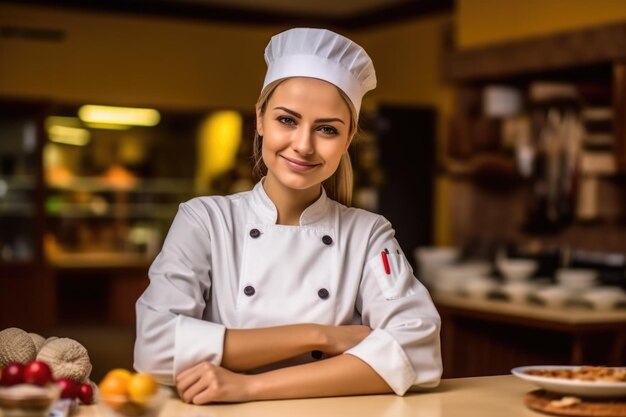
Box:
[0, 4, 277, 108]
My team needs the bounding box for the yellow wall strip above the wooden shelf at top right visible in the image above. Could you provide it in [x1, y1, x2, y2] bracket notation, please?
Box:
[456, 0, 626, 48]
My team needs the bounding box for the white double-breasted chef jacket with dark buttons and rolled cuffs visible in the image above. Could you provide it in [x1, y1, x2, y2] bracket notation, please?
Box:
[135, 182, 442, 395]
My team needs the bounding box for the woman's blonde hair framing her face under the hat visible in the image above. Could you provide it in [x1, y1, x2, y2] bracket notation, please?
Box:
[252, 78, 359, 206]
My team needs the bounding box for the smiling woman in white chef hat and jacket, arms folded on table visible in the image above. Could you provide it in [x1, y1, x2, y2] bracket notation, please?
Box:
[135, 29, 442, 404]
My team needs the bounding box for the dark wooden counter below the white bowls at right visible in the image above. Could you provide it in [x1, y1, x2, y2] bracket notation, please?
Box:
[435, 296, 626, 378]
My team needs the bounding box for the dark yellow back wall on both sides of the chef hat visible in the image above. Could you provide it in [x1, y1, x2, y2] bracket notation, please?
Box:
[0, 4, 446, 109]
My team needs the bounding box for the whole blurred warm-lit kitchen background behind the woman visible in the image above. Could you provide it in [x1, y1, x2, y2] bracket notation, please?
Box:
[0, 0, 626, 380]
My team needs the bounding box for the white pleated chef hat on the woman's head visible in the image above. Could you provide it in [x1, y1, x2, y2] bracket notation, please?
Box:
[263, 28, 376, 114]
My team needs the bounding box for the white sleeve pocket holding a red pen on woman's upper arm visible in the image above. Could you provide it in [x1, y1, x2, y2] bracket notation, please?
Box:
[367, 252, 415, 300]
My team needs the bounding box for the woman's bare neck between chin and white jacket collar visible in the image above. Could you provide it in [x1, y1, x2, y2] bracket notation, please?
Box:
[263, 175, 322, 226]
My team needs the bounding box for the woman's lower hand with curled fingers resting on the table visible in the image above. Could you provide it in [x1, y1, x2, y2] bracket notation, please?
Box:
[176, 362, 251, 404]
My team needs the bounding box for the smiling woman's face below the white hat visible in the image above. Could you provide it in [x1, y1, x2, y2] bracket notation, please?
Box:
[257, 77, 351, 192]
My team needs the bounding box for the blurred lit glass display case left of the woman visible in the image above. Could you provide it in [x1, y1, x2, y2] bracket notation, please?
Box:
[43, 106, 210, 267]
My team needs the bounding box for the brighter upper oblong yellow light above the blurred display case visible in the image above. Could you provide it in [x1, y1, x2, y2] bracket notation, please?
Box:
[78, 104, 161, 126]
